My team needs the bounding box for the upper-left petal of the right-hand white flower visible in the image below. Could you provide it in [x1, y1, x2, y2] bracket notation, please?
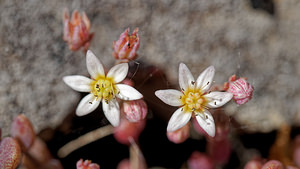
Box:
[179, 63, 195, 90]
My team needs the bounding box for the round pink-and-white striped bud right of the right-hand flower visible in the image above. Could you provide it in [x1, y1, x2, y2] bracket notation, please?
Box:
[224, 75, 253, 105]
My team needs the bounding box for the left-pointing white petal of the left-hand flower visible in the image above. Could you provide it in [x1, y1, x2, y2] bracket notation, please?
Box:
[63, 75, 93, 92]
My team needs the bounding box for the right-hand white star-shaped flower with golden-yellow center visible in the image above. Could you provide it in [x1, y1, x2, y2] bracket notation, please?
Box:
[155, 63, 232, 137]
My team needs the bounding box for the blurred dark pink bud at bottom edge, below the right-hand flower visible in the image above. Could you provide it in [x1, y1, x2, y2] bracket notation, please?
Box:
[187, 151, 214, 169]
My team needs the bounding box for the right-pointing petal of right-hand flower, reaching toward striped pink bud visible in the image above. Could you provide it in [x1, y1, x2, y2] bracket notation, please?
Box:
[204, 92, 233, 108]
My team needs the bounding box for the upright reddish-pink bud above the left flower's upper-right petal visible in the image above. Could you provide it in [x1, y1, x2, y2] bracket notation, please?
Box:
[113, 28, 140, 62]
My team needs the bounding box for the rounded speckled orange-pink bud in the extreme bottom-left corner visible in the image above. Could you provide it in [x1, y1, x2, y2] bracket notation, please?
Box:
[0, 137, 21, 169]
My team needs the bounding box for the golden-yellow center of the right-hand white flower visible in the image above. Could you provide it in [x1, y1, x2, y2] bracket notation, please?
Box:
[181, 89, 207, 113]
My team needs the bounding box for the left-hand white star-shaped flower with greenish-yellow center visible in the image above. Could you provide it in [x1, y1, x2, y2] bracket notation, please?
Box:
[63, 51, 143, 126]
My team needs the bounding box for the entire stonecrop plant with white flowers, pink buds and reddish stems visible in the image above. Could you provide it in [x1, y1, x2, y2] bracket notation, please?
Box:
[0, 9, 260, 169]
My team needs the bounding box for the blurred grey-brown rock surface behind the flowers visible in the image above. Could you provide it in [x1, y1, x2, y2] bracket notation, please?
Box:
[0, 0, 300, 136]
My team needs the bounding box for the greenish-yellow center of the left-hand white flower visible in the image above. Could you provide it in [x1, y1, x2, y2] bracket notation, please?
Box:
[91, 76, 118, 103]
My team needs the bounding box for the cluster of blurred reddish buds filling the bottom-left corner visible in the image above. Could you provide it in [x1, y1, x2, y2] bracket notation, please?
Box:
[0, 114, 62, 169]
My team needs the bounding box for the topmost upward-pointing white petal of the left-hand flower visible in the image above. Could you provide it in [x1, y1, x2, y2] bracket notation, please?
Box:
[86, 50, 105, 79]
